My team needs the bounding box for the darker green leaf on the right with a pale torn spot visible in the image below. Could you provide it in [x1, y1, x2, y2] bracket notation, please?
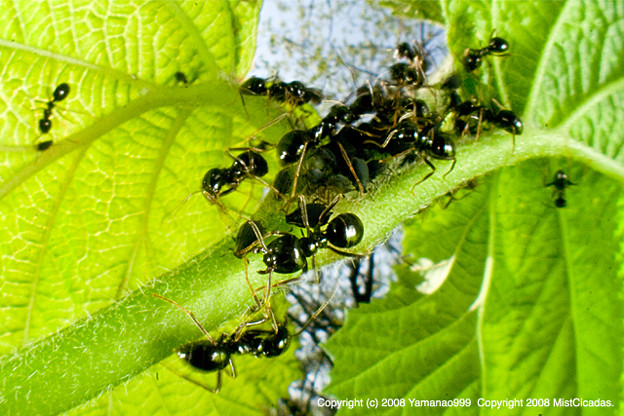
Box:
[328, 1, 624, 415]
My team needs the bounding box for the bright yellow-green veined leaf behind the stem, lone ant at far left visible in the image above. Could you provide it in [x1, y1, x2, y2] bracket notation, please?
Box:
[0, 1, 297, 414]
